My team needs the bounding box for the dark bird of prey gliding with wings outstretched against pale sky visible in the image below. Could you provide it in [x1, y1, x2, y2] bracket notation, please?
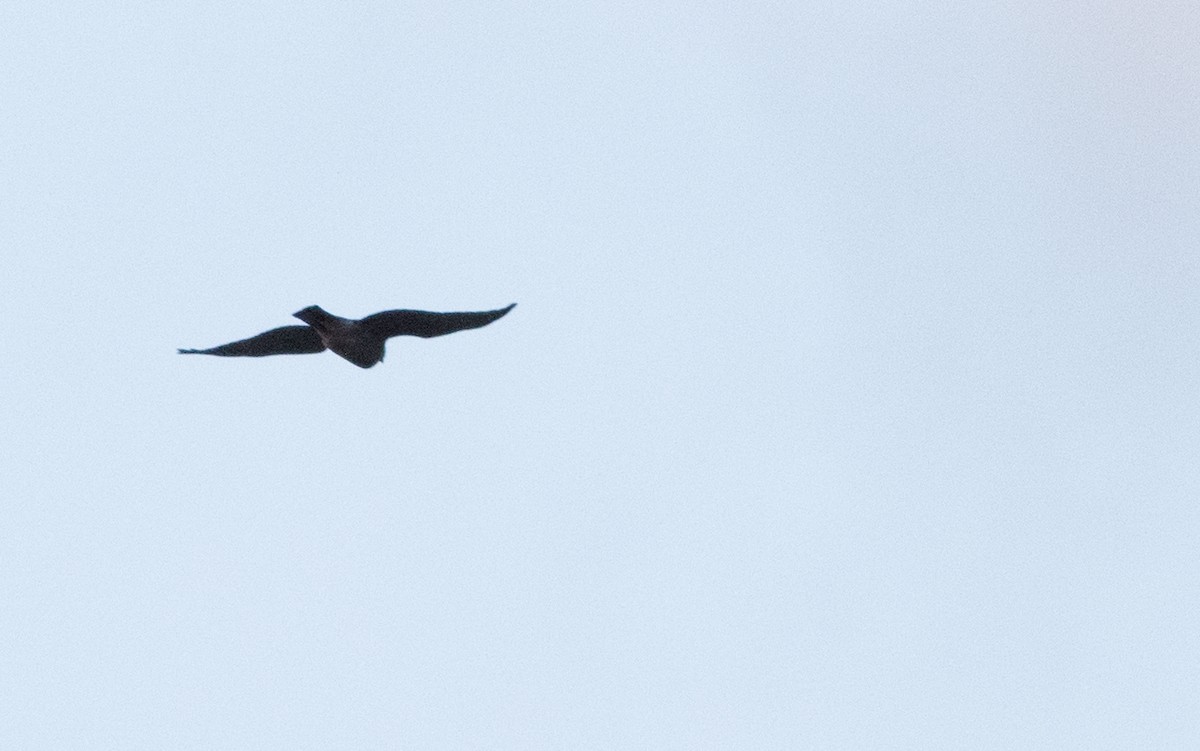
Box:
[179, 302, 517, 368]
